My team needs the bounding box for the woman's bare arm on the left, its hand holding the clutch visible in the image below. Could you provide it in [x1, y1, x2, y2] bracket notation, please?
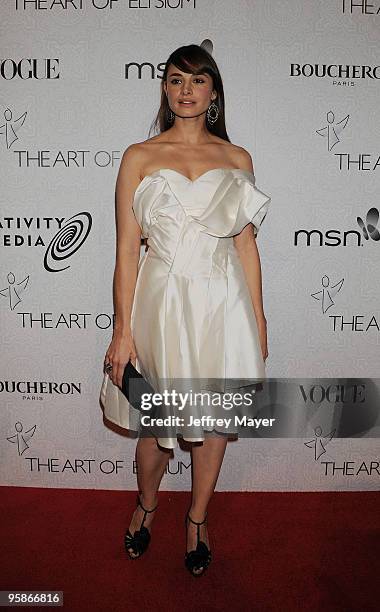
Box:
[105, 144, 142, 387]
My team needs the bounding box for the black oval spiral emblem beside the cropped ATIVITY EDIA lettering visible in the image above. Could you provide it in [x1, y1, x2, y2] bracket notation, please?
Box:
[44, 212, 92, 272]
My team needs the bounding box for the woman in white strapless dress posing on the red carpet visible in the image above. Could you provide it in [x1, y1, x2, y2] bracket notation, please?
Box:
[102, 45, 270, 576]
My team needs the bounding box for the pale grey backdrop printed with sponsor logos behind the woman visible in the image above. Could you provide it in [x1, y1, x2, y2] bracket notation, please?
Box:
[0, 0, 380, 491]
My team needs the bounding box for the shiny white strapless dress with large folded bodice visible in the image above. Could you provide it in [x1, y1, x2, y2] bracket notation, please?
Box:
[100, 168, 271, 448]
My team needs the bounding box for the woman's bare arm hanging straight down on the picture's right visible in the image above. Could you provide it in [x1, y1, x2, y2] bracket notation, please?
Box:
[233, 223, 268, 361]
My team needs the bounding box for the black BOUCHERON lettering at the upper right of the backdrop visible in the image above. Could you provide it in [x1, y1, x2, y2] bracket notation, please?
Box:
[290, 64, 380, 79]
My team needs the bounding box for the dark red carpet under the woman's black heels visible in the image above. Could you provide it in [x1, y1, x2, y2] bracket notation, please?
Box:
[0, 487, 380, 612]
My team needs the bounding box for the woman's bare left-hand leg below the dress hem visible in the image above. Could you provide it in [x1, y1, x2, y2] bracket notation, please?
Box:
[129, 437, 171, 556]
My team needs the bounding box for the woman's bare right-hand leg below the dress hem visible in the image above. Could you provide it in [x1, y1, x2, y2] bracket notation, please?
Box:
[187, 434, 227, 568]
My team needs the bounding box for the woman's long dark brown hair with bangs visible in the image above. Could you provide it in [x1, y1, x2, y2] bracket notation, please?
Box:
[149, 45, 231, 142]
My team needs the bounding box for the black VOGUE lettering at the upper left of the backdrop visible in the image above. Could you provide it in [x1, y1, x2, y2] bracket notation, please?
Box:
[0, 57, 59, 81]
